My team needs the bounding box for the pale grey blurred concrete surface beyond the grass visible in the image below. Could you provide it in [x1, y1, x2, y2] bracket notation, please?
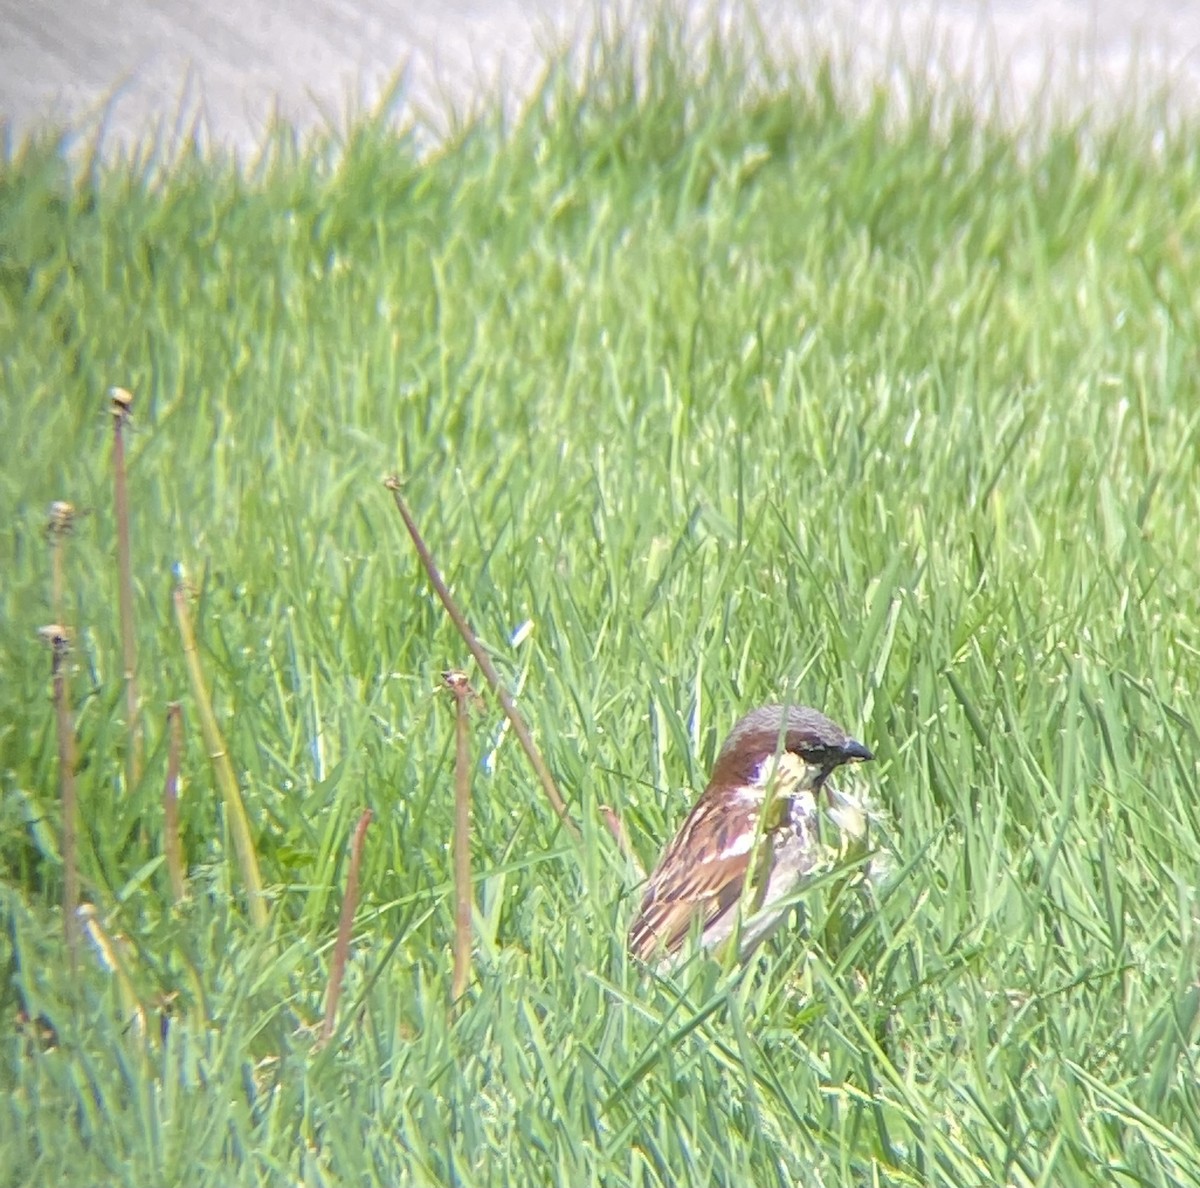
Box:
[0, 0, 1200, 150]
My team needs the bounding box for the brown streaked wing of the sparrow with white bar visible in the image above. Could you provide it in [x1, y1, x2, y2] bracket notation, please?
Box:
[629, 792, 755, 961]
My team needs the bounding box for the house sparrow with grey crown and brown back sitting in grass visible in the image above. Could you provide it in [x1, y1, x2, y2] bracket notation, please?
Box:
[629, 706, 875, 961]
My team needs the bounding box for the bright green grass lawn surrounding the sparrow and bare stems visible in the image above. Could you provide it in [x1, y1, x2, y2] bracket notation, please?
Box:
[0, 11, 1200, 1186]
